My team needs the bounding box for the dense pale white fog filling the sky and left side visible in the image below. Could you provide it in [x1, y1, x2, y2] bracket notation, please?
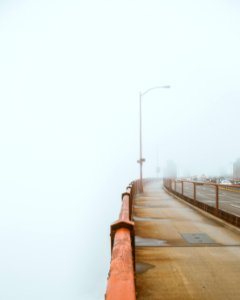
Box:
[0, 0, 240, 300]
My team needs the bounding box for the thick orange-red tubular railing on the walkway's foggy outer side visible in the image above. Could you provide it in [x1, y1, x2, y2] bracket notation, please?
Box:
[105, 181, 140, 300]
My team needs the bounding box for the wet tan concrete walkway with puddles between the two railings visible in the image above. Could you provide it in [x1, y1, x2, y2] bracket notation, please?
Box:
[133, 183, 240, 300]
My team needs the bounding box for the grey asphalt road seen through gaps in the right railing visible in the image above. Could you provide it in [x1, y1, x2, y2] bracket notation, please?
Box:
[176, 182, 240, 216]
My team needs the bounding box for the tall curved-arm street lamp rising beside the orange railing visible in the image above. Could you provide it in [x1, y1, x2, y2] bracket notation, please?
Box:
[137, 85, 170, 193]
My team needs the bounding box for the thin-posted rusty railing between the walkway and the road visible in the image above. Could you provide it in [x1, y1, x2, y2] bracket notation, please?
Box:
[163, 178, 240, 227]
